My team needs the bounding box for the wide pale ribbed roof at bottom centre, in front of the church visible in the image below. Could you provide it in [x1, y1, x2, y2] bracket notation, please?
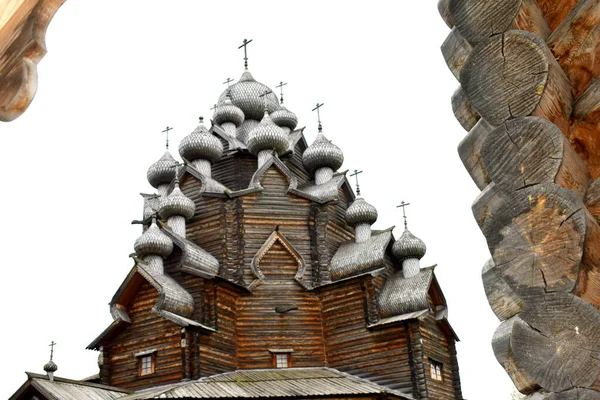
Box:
[125, 368, 412, 400]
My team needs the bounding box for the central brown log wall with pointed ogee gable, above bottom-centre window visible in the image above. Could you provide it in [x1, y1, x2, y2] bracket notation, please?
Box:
[236, 241, 326, 369]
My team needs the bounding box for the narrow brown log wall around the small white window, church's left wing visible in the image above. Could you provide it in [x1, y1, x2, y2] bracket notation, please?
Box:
[108, 281, 183, 389]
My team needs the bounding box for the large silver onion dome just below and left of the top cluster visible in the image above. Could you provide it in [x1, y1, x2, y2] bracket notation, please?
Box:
[179, 117, 223, 178]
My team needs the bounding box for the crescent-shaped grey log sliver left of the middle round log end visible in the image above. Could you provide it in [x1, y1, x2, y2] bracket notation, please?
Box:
[458, 118, 496, 190]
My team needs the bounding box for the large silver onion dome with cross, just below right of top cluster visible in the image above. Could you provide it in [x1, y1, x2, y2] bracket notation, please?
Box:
[302, 131, 344, 185]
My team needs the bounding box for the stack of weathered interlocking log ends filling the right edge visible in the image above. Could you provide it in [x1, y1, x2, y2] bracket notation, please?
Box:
[438, 0, 600, 400]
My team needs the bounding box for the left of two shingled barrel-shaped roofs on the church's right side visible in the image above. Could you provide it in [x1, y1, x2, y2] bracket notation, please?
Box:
[330, 229, 392, 281]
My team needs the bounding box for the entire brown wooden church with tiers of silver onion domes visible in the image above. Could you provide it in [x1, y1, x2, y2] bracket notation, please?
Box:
[11, 46, 462, 400]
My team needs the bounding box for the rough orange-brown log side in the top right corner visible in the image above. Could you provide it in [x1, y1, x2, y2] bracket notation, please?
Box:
[548, 0, 600, 98]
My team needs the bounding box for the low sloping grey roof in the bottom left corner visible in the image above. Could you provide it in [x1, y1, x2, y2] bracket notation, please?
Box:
[9, 372, 131, 400]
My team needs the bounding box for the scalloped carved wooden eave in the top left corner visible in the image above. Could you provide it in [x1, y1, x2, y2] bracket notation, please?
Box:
[0, 0, 65, 122]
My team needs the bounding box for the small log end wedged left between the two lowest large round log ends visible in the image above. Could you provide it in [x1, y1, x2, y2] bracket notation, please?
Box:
[481, 259, 523, 321]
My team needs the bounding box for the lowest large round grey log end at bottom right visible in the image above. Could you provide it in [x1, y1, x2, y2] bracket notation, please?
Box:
[492, 291, 600, 393]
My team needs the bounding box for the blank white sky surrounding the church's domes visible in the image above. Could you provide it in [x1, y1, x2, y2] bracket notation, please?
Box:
[0, 0, 512, 400]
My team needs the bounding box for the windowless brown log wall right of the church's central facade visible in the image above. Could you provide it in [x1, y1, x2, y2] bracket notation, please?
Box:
[318, 279, 413, 394]
